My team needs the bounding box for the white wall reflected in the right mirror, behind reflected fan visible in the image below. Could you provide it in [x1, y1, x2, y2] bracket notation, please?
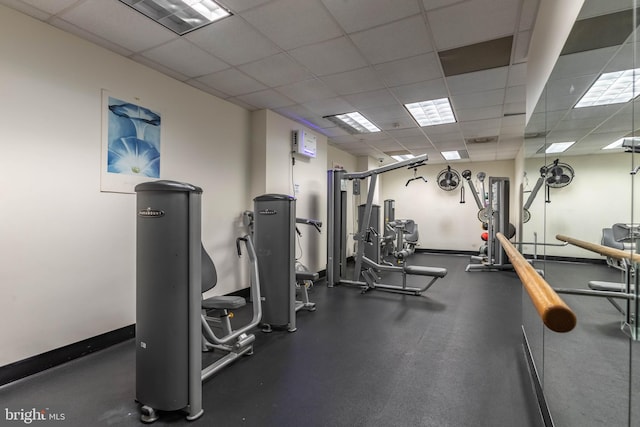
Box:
[523, 153, 637, 259]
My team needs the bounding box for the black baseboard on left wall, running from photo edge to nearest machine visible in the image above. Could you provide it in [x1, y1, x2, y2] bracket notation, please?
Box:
[0, 325, 135, 386]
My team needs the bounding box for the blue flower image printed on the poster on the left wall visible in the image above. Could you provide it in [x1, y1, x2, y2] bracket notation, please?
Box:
[107, 97, 160, 178]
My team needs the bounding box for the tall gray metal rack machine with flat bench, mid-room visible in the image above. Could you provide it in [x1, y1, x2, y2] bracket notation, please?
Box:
[327, 154, 447, 295]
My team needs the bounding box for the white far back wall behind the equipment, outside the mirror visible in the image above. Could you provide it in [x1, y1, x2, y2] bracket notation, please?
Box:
[381, 160, 516, 251]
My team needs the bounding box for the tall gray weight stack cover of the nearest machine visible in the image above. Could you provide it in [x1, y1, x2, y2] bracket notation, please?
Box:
[135, 181, 202, 411]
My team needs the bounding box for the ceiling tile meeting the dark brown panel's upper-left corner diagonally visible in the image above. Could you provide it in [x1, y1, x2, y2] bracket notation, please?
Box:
[351, 15, 433, 64]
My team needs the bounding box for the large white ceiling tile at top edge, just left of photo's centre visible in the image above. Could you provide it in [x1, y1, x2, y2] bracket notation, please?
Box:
[242, 0, 342, 50]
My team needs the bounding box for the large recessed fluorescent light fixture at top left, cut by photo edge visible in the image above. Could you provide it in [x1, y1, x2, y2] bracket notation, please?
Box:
[120, 0, 231, 35]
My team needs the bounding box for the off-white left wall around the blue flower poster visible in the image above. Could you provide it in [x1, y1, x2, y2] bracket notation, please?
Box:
[0, 7, 250, 366]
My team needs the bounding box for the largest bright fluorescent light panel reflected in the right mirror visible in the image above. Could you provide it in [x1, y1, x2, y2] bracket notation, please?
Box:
[574, 68, 640, 108]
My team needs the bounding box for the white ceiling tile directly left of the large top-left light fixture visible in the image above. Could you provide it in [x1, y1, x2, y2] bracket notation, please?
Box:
[60, 0, 178, 52]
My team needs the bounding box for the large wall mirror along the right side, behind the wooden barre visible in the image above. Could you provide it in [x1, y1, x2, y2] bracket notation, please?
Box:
[520, 0, 640, 427]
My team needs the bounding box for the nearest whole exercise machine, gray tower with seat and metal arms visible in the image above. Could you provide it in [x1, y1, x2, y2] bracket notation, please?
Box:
[135, 180, 262, 423]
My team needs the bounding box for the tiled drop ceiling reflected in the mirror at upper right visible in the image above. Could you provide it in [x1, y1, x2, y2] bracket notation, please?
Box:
[525, 0, 639, 157]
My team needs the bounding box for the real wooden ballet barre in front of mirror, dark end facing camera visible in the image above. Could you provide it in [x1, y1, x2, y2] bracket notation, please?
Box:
[496, 233, 577, 332]
